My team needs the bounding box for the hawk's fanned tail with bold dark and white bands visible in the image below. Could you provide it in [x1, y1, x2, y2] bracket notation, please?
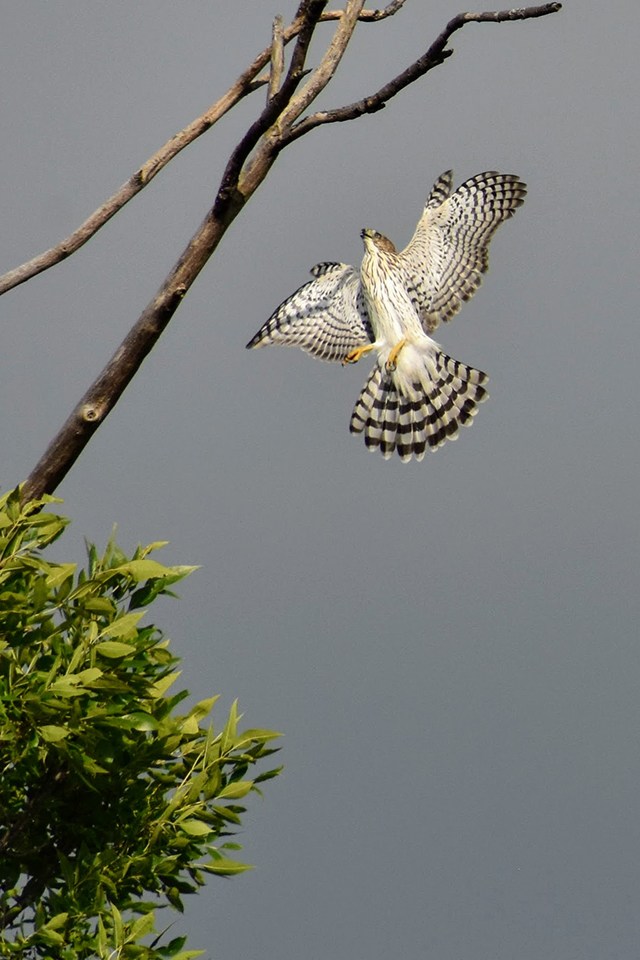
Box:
[349, 351, 489, 461]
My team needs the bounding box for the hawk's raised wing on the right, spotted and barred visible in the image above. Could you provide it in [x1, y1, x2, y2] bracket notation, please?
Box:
[400, 170, 527, 333]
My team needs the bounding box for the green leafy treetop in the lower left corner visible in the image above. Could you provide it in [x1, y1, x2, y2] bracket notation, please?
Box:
[0, 491, 279, 960]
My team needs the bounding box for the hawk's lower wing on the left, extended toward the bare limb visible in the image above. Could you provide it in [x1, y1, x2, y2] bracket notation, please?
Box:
[247, 263, 374, 360]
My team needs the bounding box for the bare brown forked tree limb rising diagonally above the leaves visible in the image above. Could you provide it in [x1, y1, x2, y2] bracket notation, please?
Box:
[18, 0, 561, 502]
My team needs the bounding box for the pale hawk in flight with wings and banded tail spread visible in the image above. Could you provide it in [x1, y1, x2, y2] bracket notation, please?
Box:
[247, 170, 527, 461]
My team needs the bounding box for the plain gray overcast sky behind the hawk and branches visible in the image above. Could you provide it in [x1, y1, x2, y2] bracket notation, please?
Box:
[0, 0, 640, 960]
